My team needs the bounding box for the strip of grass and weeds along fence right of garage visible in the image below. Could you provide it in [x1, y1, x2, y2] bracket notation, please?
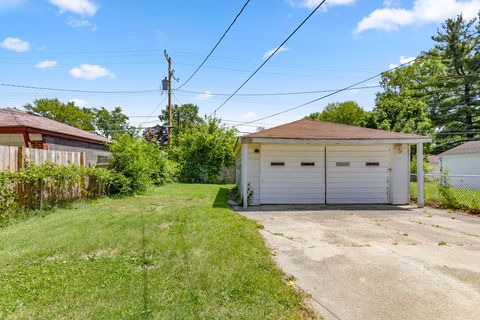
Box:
[410, 181, 480, 213]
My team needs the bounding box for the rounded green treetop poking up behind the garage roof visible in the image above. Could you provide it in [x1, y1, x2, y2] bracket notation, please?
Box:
[308, 101, 368, 126]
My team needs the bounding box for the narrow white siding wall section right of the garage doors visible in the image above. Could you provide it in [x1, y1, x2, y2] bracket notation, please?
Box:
[390, 144, 410, 204]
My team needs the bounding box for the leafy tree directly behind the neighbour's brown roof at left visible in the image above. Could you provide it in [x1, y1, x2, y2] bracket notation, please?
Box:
[24, 99, 95, 131]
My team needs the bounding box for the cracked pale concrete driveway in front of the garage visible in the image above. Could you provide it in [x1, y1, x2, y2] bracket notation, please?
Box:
[241, 206, 480, 320]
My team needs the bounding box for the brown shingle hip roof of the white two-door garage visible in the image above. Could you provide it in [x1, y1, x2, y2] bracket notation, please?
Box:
[241, 118, 430, 140]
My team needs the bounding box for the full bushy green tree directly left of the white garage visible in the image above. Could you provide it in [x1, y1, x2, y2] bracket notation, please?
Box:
[173, 117, 237, 183]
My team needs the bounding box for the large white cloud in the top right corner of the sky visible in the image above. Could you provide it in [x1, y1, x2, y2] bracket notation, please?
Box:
[355, 0, 480, 33]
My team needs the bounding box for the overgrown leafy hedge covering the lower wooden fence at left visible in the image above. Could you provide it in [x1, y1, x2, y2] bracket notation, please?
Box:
[0, 163, 114, 224]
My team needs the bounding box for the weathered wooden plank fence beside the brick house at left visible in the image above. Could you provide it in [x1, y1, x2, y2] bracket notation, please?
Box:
[0, 146, 85, 171]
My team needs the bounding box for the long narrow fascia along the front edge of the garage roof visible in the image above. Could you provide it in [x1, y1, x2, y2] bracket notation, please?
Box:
[237, 137, 432, 145]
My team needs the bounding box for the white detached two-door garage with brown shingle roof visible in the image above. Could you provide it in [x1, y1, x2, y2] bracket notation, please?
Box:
[235, 119, 431, 207]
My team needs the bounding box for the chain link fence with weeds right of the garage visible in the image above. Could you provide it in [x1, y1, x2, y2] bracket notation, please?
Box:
[410, 174, 480, 213]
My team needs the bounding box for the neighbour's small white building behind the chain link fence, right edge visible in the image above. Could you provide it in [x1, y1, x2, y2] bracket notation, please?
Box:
[440, 141, 480, 190]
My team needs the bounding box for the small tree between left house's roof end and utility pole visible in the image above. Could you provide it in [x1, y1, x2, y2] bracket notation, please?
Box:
[91, 107, 136, 138]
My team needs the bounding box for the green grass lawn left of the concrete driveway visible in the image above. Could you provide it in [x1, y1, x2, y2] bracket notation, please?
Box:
[0, 184, 307, 319]
